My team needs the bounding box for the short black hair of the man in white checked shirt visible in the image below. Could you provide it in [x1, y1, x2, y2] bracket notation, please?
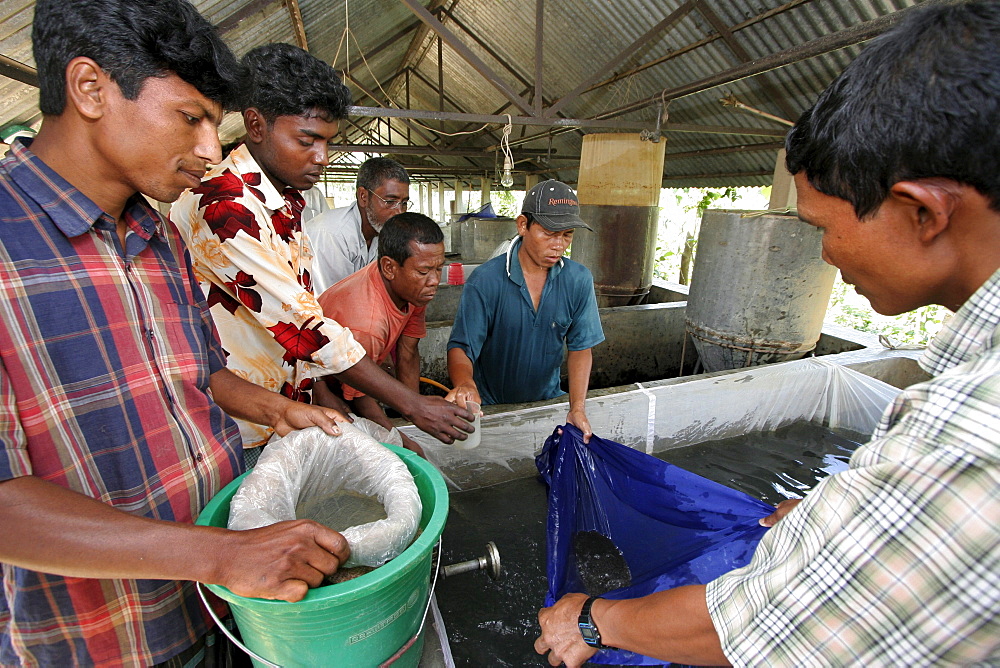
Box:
[785, 0, 1000, 218]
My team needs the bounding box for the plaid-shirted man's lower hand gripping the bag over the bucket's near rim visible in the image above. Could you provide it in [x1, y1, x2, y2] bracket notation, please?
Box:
[211, 520, 351, 603]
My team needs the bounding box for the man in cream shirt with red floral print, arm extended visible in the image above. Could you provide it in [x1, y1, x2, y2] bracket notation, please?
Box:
[170, 44, 473, 462]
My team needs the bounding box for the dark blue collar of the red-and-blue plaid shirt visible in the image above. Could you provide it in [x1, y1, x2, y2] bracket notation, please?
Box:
[4, 138, 163, 241]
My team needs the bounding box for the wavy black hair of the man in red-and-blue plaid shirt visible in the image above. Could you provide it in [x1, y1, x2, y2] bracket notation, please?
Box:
[31, 0, 241, 116]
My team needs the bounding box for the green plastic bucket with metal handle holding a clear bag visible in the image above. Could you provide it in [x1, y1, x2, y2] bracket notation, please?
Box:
[196, 445, 448, 668]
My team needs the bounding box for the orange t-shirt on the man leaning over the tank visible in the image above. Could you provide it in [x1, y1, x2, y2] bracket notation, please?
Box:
[319, 261, 427, 400]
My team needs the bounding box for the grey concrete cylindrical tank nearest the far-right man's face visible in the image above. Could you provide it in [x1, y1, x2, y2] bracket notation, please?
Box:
[685, 210, 837, 371]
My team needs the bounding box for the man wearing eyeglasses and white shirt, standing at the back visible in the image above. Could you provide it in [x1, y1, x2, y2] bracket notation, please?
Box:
[302, 158, 410, 295]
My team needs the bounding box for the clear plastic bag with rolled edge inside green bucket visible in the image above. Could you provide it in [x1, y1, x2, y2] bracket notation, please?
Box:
[229, 418, 422, 568]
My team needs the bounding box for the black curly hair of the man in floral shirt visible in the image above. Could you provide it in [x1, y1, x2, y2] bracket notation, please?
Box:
[243, 42, 351, 123]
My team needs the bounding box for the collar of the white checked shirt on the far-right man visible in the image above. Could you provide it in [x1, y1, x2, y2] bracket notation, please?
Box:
[920, 269, 1000, 376]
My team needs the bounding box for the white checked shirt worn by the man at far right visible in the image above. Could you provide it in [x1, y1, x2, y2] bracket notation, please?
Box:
[707, 271, 1000, 666]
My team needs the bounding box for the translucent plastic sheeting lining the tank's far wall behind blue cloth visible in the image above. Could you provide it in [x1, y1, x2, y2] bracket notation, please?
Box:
[400, 351, 913, 489]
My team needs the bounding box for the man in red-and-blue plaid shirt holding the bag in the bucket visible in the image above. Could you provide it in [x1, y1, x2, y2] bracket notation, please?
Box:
[0, 0, 358, 666]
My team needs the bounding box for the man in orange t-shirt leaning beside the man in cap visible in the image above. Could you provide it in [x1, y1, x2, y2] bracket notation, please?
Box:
[319, 213, 444, 455]
